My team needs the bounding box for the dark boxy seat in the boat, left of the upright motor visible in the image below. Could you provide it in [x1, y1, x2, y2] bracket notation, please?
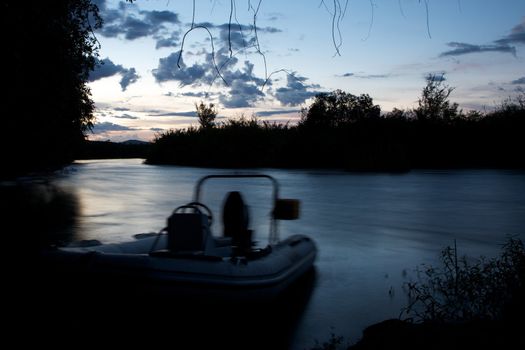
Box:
[167, 212, 210, 252]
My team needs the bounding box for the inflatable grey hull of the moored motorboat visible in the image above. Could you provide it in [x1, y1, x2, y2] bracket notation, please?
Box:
[43, 235, 317, 301]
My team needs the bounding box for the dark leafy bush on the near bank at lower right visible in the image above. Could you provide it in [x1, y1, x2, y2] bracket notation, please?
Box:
[404, 238, 525, 322]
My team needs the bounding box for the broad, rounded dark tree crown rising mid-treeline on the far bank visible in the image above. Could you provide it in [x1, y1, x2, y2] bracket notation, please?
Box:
[300, 90, 381, 127]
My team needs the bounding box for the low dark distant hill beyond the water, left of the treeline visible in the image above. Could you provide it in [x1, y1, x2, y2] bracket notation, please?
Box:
[75, 140, 151, 159]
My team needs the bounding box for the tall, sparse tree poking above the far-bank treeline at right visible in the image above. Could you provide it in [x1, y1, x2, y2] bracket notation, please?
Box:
[414, 74, 458, 121]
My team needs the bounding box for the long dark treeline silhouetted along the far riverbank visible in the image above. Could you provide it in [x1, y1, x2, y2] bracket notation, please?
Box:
[147, 76, 525, 171]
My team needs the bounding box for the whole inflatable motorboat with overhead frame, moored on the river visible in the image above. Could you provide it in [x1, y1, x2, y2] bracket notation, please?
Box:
[43, 174, 317, 301]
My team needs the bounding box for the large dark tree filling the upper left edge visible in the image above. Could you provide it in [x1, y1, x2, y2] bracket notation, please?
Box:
[0, 0, 102, 176]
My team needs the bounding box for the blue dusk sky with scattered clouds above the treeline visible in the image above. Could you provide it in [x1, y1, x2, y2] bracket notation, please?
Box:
[89, 0, 525, 142]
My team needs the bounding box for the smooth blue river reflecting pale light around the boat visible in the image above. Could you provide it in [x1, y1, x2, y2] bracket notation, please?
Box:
[45, 159, 525, 349]
